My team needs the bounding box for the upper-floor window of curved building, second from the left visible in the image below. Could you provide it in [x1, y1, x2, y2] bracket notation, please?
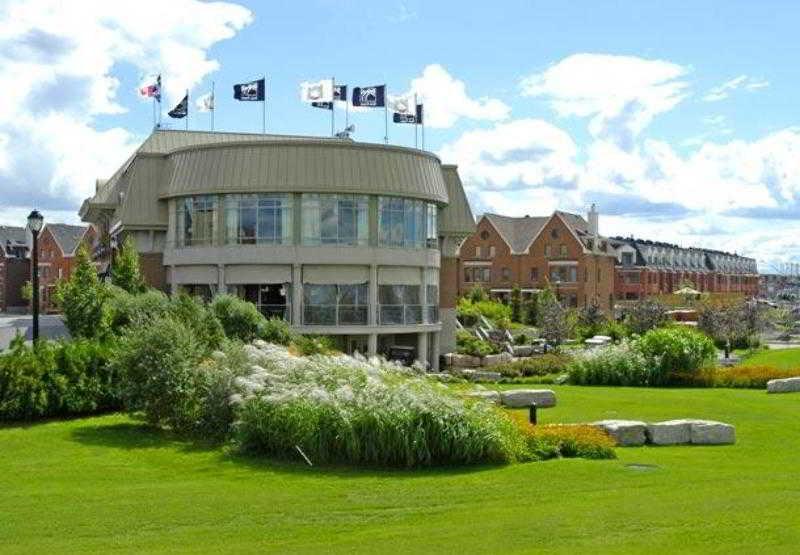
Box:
[225, 195, 292, 245]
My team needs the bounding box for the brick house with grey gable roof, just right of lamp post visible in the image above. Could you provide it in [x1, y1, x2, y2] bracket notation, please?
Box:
[38, 223, 96, 310]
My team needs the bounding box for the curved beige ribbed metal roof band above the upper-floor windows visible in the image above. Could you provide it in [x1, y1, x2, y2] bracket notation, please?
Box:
[157, 137, 448, 203]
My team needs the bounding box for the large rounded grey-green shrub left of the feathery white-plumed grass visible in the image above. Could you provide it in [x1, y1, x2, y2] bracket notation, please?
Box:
[111, 316, 204, 431]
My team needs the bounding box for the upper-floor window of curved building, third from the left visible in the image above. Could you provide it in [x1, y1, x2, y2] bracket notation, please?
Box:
[302, 194, 369, 246]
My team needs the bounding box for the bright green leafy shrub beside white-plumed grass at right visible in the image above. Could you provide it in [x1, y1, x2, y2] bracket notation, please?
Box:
[636, 326, 717, 385]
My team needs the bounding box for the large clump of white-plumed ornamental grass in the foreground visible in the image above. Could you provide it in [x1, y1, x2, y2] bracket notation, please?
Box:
[235, 346, 525, 467]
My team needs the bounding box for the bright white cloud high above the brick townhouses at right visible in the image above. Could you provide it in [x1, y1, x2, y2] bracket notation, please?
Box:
[521, 54, 688, 148]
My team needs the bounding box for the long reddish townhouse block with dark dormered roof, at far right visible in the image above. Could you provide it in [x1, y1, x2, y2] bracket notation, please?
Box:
[611, 237, 759, 301]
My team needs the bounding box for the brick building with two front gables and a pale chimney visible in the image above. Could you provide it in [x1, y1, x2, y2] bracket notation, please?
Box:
[458, 207, 616, 310]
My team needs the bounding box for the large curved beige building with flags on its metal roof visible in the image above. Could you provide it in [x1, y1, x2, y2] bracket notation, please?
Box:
[80, 130, 475, 368]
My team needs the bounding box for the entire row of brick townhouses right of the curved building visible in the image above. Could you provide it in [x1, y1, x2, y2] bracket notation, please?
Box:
[458, 205, 758, 310]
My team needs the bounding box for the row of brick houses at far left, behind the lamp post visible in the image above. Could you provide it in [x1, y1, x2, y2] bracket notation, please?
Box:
[0, 223, 96, 312]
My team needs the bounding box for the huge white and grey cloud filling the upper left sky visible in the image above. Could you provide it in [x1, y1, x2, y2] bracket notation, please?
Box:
[0, 0, 252, 224]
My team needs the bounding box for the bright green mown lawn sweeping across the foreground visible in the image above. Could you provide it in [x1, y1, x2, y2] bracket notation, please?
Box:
[0, 386, 800, 554]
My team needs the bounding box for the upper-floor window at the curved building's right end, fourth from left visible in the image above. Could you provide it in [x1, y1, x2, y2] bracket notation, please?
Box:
[378, 197, 430, 249]
